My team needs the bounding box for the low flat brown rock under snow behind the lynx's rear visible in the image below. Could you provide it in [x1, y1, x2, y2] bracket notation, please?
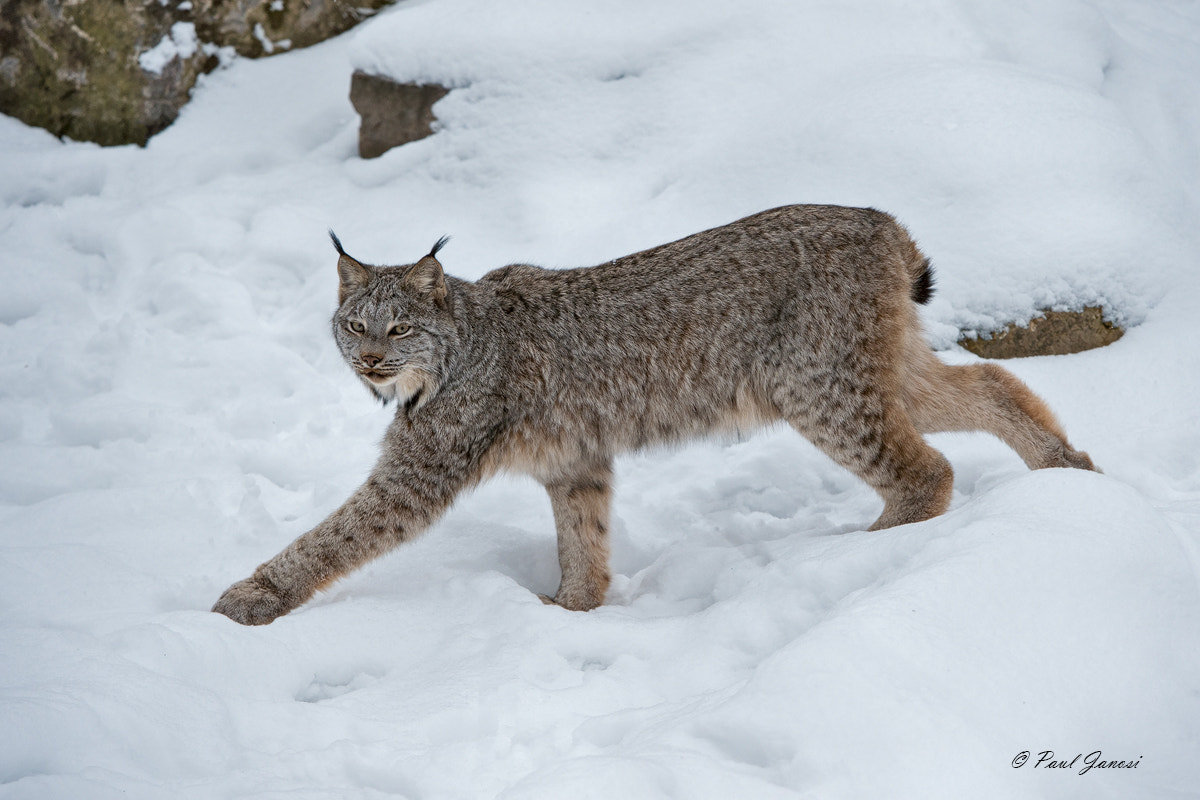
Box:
[959, 306, 1124, 359]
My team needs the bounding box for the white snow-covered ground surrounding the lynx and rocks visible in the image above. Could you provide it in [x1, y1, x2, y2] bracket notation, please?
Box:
[0, 0, 1200, 800]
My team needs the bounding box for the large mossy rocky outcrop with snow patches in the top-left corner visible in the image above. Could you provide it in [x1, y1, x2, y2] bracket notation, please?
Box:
[0, 0, 394, 145]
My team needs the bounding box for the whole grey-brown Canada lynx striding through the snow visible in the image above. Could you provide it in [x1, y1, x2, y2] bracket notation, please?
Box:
[214, 205, 1094, 625]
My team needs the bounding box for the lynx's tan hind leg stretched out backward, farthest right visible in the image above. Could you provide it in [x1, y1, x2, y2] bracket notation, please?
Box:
[904, 343, 1098, 471]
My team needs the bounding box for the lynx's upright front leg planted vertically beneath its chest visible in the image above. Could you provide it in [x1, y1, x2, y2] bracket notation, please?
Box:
[544, 462, 612, 610]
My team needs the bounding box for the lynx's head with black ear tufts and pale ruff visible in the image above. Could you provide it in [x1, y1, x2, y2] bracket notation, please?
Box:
[329, 230, 458, 409]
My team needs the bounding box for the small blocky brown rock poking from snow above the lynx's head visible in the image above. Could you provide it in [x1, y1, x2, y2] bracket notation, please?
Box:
[350, 71, 450, 158]
